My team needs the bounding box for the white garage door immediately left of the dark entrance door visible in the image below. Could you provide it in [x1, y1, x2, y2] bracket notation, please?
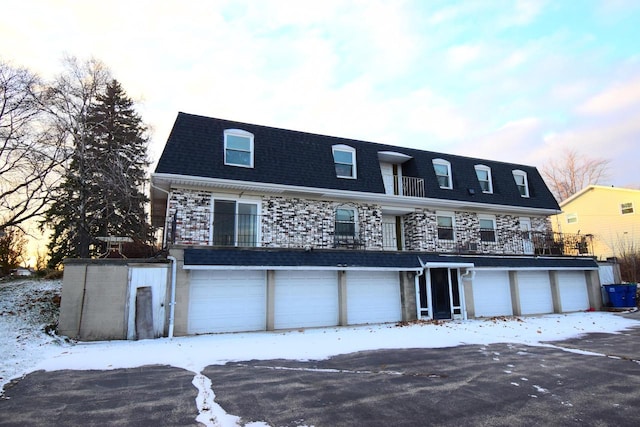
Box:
[347, 271, 402, 325]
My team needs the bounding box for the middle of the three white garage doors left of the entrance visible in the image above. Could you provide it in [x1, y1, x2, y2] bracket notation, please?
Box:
[274, 270, 338, 329]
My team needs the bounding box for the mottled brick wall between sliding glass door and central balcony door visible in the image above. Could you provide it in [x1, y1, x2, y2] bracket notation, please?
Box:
[262, 196, 382, 249]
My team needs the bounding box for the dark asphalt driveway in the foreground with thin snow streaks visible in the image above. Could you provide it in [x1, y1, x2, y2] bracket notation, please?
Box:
[0, 314, 640, 427]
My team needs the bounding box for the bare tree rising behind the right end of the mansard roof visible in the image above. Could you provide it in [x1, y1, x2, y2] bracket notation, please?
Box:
[541, 148, 609, 201]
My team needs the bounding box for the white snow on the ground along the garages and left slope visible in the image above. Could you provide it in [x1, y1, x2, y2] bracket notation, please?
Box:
[0, 280, 640, 425]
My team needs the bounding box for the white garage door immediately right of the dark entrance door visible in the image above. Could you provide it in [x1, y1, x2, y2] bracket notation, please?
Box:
[473, 271, 513, 317]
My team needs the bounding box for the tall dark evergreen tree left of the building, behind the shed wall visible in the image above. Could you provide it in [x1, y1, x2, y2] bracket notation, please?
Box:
[46, 80, 153, 265]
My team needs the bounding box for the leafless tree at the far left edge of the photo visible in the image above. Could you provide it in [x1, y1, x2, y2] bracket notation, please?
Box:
[0, 62, 63, 229]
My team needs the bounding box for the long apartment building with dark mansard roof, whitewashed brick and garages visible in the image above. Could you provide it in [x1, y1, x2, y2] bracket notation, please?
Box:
[139, 113, 601, 335]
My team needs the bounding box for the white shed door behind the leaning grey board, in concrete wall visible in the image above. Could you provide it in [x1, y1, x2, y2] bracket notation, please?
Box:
[127, 265, 169, 340]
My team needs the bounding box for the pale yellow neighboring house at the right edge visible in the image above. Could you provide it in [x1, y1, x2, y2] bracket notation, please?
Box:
[552, 185, 640, 260]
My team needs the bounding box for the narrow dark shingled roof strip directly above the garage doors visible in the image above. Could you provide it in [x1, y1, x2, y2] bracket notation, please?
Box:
[184, 248, 598, 270]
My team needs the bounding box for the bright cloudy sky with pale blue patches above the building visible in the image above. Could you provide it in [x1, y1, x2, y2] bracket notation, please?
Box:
[0, 0, 640, 187]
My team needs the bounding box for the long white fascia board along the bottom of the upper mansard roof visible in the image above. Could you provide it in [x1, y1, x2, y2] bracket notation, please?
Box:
[151, 173, 560, 216]
